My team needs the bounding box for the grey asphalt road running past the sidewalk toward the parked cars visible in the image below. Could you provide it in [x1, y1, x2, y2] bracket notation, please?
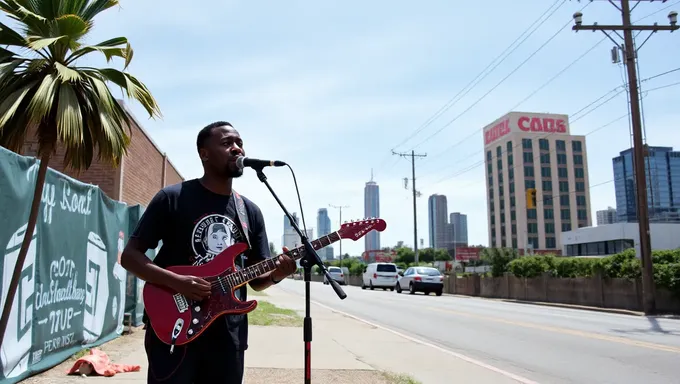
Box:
[279, 279, 680, 384]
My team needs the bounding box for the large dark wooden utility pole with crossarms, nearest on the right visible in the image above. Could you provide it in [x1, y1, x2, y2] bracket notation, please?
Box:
[572, 0, 679, 315]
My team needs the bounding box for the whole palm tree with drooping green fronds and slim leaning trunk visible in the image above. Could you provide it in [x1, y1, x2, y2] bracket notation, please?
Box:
[0, 0, 161, 344]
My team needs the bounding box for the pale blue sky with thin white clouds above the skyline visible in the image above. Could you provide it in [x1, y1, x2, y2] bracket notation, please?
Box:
[6, 0, 680, 256]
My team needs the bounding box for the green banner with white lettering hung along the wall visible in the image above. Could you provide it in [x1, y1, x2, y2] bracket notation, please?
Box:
[0, 147, 143, 384]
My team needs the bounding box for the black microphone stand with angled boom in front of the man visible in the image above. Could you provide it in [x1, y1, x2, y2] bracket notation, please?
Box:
[252, 167, 347, 384]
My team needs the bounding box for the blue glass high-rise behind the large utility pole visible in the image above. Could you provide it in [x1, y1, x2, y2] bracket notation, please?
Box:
[612, 147, 680, 222]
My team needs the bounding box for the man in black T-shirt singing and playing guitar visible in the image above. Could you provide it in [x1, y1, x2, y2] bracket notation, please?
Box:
[121, 122, 296, 384]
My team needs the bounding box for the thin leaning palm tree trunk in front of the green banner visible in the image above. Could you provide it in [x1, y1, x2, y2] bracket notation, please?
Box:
[0, 150, 52, 345]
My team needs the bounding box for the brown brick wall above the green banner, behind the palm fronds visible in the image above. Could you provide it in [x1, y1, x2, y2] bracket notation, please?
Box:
[20, 101, 184, 206]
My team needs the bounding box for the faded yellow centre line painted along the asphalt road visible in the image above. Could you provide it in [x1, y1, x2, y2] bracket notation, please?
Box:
[425, 307, 680, 353]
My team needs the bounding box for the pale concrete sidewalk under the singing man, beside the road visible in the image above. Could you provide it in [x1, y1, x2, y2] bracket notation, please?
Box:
[19, 287, 515, 384]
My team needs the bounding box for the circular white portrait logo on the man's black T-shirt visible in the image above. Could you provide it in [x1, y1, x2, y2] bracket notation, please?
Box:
[191, 214, 240, 265]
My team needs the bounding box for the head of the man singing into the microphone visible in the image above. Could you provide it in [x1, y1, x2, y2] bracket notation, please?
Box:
[196, 121, 245, 178]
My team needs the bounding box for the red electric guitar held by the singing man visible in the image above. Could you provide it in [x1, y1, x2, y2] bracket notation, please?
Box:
[143, 218, 387, 351]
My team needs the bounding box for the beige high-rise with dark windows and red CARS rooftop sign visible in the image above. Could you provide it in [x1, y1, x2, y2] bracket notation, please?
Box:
[484, 112, 592, 252]
